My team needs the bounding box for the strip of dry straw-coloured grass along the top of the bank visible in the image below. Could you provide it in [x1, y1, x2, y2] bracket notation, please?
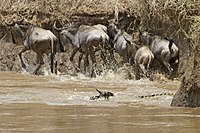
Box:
[0, 0, 200, 30]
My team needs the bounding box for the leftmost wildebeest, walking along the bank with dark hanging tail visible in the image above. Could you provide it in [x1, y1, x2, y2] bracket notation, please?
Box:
[7, 22, 57, 74]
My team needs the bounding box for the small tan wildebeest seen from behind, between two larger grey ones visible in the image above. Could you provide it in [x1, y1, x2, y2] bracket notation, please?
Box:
[134, 46, 154, 76]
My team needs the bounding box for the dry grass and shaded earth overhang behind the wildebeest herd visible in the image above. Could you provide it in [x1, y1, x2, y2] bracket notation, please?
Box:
[0, 0, 200, 45]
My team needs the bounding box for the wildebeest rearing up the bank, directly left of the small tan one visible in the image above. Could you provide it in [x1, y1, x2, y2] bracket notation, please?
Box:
[108, 22, 136, 64]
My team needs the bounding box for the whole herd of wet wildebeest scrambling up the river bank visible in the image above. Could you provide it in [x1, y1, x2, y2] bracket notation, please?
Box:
[6, 16, 179, 77]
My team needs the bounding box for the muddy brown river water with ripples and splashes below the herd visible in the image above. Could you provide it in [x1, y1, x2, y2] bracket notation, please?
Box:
[0, 72, 200, 133]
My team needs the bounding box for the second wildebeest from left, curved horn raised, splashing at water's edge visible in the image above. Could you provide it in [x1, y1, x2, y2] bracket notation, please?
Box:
[54, 23, 109, 73]
